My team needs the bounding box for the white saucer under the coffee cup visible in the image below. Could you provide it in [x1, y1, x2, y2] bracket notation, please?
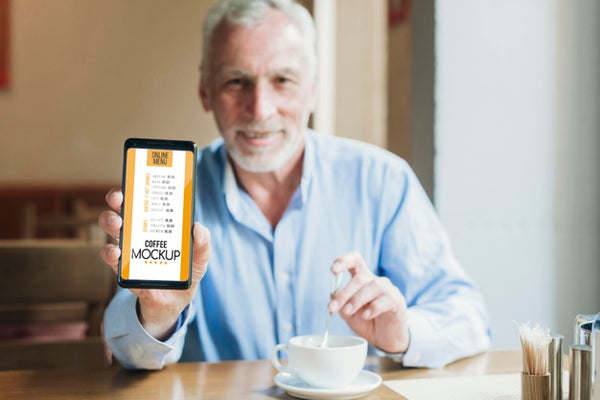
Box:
[273, 370, 381, 400]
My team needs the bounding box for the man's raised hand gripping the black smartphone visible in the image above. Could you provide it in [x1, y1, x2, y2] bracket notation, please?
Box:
[98, 189, 211, 340]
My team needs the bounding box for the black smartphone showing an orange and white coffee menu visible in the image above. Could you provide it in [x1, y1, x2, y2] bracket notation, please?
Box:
[118, 138, 196, 289]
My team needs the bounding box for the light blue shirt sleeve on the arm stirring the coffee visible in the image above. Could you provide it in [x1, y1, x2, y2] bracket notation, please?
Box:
[380, 161, 490, 368]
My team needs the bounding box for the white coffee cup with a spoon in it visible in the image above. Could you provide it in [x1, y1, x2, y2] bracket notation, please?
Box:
[271, 335, 367, 388]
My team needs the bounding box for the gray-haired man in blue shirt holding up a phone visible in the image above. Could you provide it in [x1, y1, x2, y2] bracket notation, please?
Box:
[100, 0, 489, 369]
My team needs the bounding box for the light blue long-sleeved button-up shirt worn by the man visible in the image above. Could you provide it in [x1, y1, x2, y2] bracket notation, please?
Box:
[104, 131, 490, 369]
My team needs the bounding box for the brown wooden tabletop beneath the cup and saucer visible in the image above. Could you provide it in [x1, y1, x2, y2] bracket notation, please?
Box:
[0, 350, 521, 400]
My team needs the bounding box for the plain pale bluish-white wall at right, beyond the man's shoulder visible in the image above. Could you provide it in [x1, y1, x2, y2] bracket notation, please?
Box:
[435, 0, 600, 347]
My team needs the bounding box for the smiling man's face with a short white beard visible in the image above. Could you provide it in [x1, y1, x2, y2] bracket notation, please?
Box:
[200, 10, 316, 172]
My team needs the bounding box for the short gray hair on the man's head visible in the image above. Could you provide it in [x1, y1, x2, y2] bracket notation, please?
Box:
[200, 0, 317, 77]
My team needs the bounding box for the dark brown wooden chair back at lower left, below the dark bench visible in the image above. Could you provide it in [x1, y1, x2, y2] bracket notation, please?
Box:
[0, 240, 116, 370]
